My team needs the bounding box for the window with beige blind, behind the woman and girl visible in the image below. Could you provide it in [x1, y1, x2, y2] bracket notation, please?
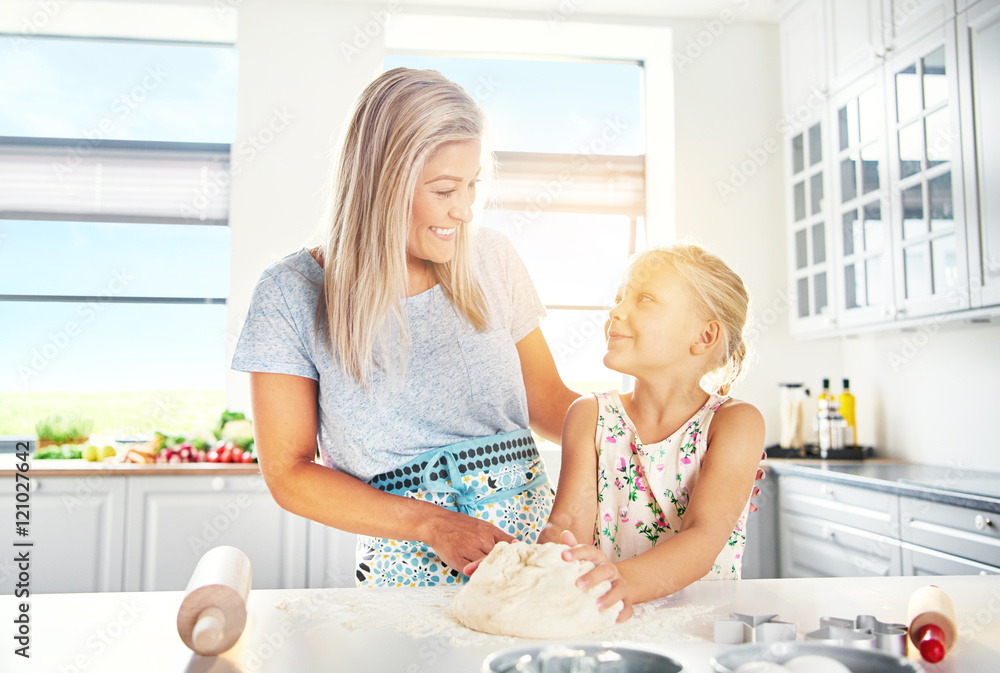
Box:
[384, 16, 674, 412]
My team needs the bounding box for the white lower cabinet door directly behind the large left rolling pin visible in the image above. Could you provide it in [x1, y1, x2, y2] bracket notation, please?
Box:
[125, 476, 308, 591]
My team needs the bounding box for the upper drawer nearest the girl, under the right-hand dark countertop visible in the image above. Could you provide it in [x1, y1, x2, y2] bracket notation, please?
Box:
[778, 476, 899, 538]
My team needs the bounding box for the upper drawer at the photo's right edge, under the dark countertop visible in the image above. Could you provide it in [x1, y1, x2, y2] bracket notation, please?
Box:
[899, 497, 1000, 567]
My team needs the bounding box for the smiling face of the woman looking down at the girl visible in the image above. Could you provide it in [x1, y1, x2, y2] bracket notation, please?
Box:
[406, 140, 481, 268]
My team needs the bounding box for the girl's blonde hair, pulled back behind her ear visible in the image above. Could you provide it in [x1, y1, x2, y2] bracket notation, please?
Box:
[632, 243, 750, 395]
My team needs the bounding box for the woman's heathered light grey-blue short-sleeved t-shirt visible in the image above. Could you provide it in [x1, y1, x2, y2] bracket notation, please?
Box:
[232, 228, 545, 481]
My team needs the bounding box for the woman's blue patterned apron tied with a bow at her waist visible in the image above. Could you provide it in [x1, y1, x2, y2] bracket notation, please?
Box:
[355, 430, 553, 587]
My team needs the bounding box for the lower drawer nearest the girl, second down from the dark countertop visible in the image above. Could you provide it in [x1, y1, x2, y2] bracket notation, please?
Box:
[779, 512, 902, 577]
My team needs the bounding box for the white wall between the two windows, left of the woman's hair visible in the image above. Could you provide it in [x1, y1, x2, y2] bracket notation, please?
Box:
[226, 0, 383, 411]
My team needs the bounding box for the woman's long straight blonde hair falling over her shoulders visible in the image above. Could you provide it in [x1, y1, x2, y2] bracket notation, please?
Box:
[316, 68, 490, 385]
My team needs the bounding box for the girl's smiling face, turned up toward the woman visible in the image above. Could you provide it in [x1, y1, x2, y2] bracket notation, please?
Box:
[604, 259, 702, 376]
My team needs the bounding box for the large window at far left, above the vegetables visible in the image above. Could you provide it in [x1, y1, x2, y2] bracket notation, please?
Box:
[0, 36, 238, 432]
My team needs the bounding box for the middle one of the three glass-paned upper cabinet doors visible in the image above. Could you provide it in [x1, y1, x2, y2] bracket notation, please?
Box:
[831, 72, 895, 327]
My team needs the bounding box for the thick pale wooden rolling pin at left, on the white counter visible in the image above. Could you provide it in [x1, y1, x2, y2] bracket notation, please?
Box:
[177, 546, 252, 656]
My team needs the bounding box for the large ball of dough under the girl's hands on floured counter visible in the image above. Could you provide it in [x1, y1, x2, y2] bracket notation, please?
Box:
[452, 542, 623, 638]
